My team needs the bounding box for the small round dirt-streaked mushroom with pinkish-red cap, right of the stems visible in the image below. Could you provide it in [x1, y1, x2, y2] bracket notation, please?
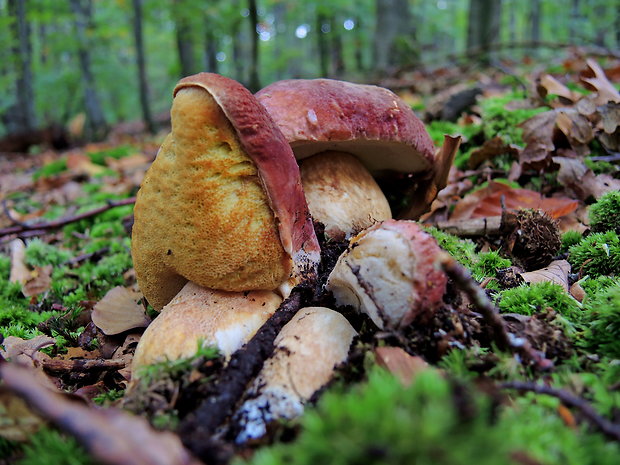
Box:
[327, 220, 448, 329]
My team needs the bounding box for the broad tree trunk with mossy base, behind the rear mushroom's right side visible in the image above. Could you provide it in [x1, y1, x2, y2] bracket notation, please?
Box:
[373, 0, 420, 74]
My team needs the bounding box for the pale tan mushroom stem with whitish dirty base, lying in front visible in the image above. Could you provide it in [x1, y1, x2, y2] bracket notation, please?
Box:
[235, 307, 357, 443]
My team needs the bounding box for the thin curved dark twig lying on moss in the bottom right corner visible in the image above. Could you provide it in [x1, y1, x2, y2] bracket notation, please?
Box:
[500, 381, 620, 442]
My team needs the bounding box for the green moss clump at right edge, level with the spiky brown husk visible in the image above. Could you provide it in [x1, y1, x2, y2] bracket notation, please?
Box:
[568, 231, 620, 277]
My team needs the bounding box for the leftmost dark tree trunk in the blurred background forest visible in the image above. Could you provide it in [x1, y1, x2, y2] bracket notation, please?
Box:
[7, 0, 36, 132]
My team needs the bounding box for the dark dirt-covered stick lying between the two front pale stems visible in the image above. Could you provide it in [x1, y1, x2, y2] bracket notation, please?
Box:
[179, 287, 305, 459]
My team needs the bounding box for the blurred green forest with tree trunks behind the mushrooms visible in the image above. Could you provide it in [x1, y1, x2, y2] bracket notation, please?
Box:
[0, 0, 620, 143]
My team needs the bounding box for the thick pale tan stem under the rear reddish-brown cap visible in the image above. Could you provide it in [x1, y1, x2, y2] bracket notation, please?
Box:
[301, 151, 392, 240]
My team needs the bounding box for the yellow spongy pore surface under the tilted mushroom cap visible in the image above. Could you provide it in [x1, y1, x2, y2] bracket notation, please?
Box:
[132, 88, 291, 309]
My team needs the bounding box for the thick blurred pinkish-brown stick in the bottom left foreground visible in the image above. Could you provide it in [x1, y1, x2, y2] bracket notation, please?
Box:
[0, 362, 202, 465]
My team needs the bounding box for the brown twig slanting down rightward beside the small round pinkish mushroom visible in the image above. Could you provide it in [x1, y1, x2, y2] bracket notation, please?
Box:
[440, 253, 553, 370]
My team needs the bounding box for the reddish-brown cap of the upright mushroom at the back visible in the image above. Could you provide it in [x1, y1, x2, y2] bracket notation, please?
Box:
[256, 79, 435, 174]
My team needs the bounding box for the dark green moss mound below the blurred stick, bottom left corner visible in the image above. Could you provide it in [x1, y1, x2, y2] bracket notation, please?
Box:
[17, 428, 95, 465]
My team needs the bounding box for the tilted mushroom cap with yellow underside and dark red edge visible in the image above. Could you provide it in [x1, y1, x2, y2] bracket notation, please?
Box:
[132, 73, 320, 309]
